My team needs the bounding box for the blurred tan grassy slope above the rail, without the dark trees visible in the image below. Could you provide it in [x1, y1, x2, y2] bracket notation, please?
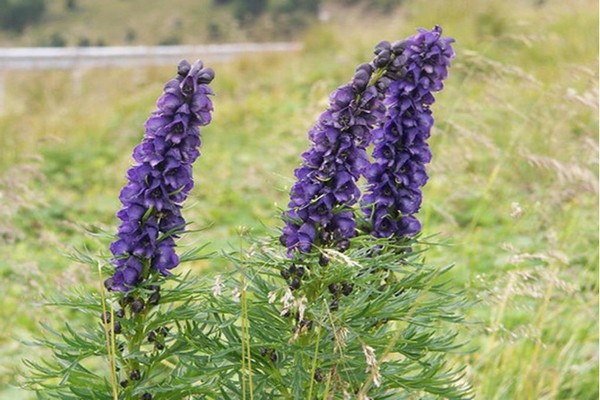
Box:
[0, 0, 316, 46]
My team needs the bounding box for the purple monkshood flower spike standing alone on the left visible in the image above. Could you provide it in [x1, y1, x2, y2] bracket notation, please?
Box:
[105, 61, 214, 291]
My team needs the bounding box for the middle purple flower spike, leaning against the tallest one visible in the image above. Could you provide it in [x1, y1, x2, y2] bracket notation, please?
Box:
[281, 62, 389, 254]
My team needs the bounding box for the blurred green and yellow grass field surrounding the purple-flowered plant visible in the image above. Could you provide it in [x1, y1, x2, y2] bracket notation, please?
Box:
[0, 0, 599, 400]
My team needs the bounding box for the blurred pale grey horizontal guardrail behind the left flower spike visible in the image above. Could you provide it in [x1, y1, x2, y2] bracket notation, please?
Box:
[0, 42, 301, 70]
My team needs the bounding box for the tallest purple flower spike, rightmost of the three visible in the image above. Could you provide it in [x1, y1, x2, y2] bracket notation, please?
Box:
[362, 26, 454, 237]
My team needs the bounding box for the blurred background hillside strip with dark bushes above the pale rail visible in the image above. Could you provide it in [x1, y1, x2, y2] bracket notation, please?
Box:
[0, 0, 322, 46]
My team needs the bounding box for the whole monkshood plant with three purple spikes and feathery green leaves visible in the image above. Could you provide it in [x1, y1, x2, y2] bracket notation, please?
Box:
[28, 27, 471, 400]
